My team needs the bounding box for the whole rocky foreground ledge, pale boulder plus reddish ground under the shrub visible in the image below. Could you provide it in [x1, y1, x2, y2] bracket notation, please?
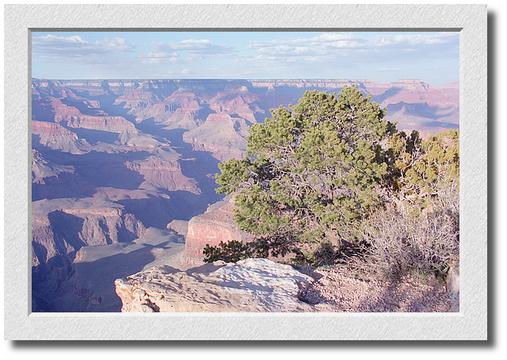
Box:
[115, 259, 459, 312]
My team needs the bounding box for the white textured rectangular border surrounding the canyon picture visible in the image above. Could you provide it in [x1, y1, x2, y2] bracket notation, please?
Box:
[4, 5, 487, 340]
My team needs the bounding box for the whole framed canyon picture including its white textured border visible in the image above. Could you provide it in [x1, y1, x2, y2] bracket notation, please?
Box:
[5, 5, 487, 340]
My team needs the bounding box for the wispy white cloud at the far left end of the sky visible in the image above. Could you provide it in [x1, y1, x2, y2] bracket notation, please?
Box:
[32, 34, 132, 58]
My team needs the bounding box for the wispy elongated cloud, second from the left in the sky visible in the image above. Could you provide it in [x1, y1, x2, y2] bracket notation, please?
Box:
[141, 39, 233, 64]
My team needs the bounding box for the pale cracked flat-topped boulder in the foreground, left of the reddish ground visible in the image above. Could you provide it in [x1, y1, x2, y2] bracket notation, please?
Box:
[115, 259, 313, 312]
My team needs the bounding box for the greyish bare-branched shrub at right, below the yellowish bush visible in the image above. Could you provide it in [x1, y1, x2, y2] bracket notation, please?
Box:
[353, 185, 459, 278]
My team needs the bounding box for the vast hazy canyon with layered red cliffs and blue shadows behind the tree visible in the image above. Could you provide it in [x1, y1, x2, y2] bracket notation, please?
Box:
[31, 79, 459, 311]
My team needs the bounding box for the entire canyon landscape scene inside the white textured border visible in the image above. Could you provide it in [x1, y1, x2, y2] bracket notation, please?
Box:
[32, 32, 459, 312]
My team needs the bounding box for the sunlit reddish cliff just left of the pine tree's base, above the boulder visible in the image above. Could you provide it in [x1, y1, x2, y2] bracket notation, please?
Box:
[185, 200, 251, 257]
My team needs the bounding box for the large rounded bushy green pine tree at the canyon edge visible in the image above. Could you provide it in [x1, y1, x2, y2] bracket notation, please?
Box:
[217, 87, 394, 252]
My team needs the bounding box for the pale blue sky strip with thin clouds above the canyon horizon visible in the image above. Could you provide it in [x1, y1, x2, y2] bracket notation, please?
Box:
[32, 32, 459, 84]
